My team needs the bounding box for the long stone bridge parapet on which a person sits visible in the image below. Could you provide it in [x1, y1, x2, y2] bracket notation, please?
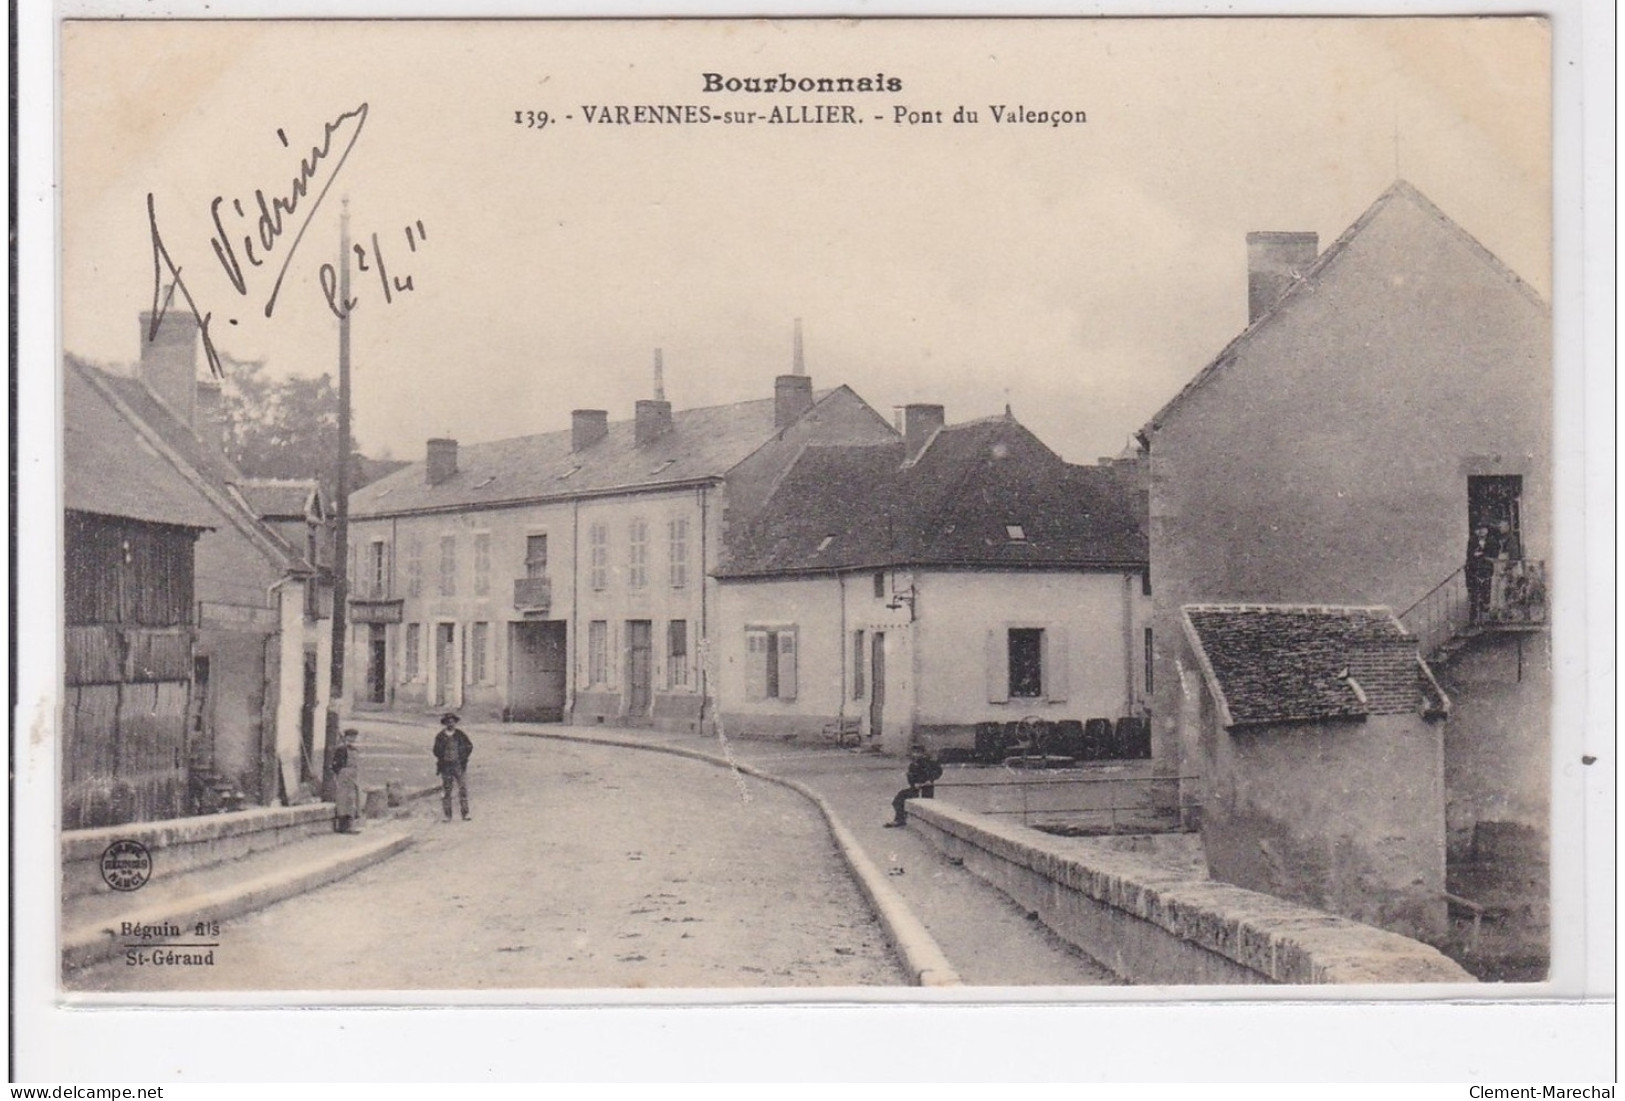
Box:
[908, 799, 1474, 986]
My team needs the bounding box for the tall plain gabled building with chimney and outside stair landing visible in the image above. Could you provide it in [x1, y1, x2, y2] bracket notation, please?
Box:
[1141, 182, 1552, 928]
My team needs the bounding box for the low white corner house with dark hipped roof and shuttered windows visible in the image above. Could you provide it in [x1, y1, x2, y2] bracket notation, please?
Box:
[717, 404, 1151, 753]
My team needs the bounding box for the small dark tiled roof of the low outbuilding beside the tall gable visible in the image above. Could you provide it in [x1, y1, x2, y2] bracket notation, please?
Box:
[1181, 604, 1450, 728]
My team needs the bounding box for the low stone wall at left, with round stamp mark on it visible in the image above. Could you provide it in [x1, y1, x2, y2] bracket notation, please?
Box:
[62, 802, 333, 898]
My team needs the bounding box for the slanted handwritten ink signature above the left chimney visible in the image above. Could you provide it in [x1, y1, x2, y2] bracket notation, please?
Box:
[146, 104, 372, 377]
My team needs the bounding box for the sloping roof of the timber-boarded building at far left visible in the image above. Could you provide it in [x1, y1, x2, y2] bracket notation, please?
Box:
[63, 356, 307, 570]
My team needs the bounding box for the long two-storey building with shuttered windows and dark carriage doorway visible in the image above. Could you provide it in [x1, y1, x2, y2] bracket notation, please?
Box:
[348, 362, 895, 729]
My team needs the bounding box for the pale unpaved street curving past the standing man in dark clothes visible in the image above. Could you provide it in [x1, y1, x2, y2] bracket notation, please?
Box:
[75, 729, 905, 991]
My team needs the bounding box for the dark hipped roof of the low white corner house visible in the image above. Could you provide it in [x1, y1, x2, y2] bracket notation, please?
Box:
[717, 416, 1147, 576]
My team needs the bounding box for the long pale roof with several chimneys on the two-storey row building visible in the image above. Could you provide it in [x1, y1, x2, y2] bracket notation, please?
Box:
[349, 386, 856, 516]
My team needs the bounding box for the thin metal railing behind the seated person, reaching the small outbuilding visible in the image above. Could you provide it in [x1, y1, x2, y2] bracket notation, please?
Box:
[936, 773, 1201, 833]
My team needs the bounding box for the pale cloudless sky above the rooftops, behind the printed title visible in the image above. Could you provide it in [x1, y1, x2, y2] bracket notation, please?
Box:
[62, 18, 1550, 461]
